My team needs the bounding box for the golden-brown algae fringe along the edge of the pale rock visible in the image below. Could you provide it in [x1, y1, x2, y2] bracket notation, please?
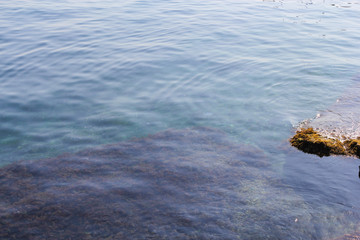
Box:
[290, 128, 360, 158]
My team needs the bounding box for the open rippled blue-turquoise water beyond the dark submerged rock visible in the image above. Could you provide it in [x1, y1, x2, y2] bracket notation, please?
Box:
[0, 1, 360, 162]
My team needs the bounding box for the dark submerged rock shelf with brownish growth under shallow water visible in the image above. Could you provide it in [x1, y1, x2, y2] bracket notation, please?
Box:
[0, 128, 358, 239]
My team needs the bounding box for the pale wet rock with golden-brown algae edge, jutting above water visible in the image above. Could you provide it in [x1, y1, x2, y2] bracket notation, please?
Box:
[290, 80, 360, 158]
